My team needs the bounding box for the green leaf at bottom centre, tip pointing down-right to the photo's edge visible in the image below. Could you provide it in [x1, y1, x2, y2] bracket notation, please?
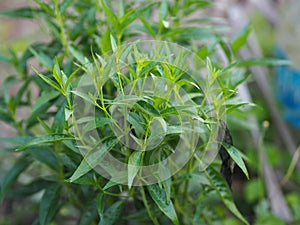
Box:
[147, 184, 179, 225]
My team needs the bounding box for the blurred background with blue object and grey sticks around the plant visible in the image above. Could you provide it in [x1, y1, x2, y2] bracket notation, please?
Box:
[0, 0, 300, 225]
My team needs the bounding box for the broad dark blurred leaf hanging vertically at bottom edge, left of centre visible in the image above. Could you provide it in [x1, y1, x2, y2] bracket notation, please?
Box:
[39, 184, 61, 225]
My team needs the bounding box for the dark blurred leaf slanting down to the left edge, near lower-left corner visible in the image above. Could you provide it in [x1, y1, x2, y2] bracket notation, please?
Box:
[0, 158, 31, 202]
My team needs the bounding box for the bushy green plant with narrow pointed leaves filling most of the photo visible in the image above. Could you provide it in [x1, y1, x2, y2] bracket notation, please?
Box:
[0, 0, 284, 225]
